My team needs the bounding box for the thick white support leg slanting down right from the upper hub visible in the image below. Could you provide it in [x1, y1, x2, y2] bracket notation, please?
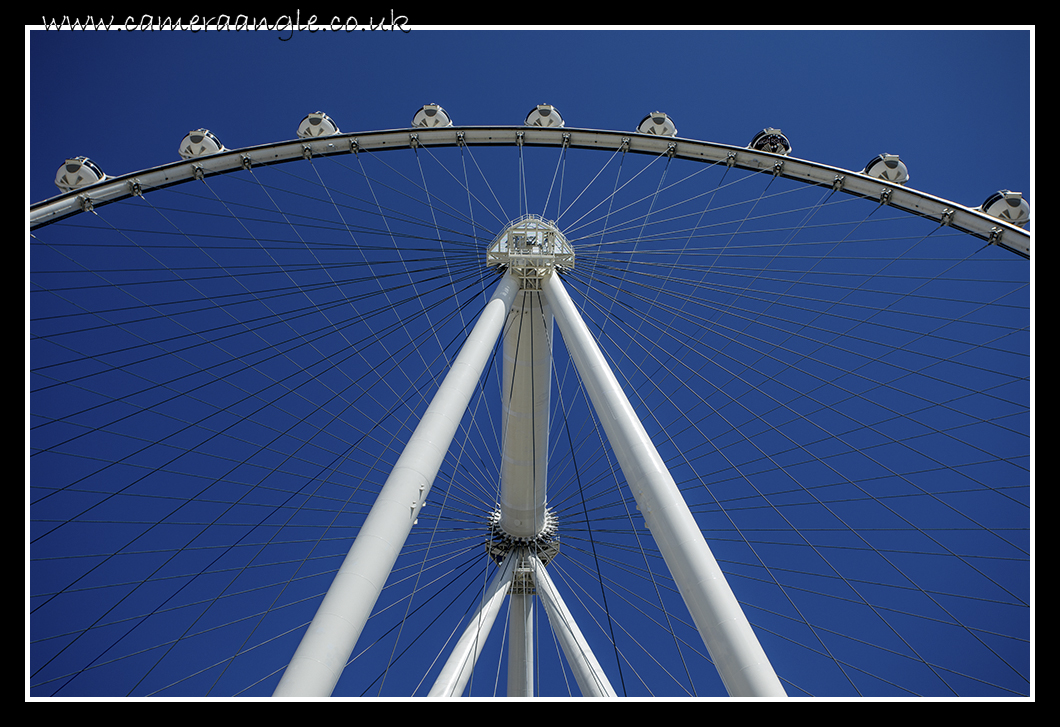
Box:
[542, 273, 787, 696]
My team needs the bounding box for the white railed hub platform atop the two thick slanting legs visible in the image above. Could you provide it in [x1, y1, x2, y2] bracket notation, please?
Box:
[485, 214, 575, 290]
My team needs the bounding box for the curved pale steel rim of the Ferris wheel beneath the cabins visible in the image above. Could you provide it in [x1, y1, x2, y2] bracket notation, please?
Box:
[30, 126, 1030, 258]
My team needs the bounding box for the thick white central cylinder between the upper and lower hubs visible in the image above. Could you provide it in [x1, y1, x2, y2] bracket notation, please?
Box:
[499, 290, 552, 538]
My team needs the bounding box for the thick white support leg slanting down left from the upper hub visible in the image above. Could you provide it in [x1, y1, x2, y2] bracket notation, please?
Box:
[272, 274, 518, 696]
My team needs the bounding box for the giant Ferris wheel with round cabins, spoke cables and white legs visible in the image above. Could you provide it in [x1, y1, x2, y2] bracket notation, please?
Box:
[29, 104, 1031, 697]
